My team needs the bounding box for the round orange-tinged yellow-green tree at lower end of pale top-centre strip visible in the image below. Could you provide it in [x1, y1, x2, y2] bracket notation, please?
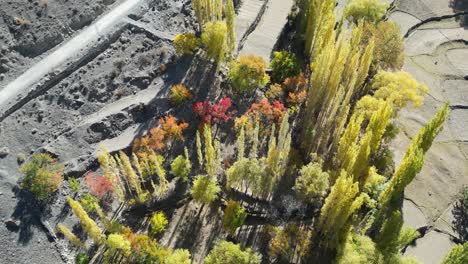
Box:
[228, 55, 269, 93]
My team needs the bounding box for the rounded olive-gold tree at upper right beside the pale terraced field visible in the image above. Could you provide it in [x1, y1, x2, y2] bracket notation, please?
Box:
[361, 21, 405, 72]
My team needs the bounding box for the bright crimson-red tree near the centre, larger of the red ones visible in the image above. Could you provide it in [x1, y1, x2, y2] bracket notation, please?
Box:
[192, 97, 234, 127]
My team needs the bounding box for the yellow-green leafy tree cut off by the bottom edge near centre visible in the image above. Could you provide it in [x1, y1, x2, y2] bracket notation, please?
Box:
[204, 241, 262, 264]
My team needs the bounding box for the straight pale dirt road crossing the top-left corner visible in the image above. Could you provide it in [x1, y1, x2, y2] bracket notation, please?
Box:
[0, 0, 147, 115]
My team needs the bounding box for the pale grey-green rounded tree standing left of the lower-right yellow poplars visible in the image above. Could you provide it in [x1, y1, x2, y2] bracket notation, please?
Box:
[294, 162, 330, 202]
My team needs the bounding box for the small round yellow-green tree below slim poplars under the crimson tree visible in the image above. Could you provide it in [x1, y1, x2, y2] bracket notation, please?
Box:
[190, 175, 221, 204]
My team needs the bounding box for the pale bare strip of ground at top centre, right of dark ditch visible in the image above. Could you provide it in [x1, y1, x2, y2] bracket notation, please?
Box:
[240, 0, 294, 62]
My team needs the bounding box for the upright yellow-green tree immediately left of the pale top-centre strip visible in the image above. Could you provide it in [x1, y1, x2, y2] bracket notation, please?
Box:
[201, 21, 227, 62]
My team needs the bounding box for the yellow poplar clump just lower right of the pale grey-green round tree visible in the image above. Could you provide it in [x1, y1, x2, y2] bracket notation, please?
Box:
[318, 171, 368, 249]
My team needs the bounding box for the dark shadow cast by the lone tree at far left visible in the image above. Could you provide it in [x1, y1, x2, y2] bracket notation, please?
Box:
[7, 186, 53, 245]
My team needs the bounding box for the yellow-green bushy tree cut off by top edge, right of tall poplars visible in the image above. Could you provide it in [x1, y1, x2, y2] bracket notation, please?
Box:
[344, 0, 389, 23]
